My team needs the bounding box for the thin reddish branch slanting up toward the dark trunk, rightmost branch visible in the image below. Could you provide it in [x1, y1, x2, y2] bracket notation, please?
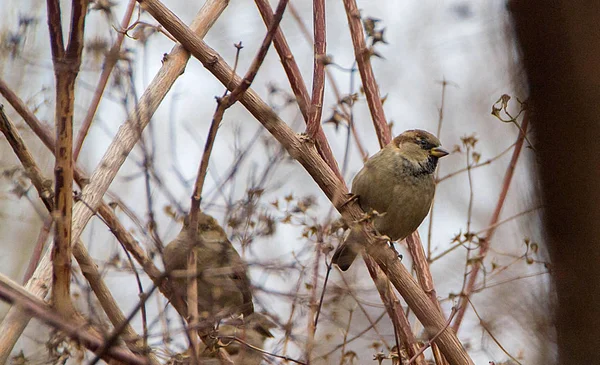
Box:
[452, 110, 529, 332]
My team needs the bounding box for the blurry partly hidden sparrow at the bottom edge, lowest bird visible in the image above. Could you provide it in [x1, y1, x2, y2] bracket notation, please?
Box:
[168, 313, 276, 365]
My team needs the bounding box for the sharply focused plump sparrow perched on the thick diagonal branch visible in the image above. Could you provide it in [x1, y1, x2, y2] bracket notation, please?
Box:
[333, 129, 448, 271]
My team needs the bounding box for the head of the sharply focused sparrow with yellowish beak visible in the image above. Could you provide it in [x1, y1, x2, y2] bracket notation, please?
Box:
[391, 129, 448, 173]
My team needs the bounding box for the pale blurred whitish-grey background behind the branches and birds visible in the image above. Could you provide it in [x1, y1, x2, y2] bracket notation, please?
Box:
[0, 0, 556, 364]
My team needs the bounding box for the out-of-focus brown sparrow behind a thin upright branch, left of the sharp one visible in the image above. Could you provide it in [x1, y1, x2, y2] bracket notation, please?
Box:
[163, 213, 254, 322]
